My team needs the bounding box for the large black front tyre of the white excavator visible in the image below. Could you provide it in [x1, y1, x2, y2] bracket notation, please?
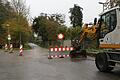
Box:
[95, 53, 115, 72]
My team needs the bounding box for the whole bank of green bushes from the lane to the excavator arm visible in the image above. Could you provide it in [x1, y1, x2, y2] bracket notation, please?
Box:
[32, 13, 81, 47]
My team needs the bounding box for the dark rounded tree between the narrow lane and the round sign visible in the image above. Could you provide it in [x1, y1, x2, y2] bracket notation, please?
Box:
[32, 14, 59, 41]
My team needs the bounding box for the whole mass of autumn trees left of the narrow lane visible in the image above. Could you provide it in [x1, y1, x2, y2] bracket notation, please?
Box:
[0, 0, 31, 46]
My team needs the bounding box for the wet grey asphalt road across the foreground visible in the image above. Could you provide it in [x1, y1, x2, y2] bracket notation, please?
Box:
[0, 43, 120, 80]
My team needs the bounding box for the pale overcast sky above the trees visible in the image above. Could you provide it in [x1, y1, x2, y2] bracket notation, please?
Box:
[26, 0, 106, 25]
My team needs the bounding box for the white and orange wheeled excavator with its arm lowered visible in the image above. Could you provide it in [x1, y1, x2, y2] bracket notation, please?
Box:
[70, 0, 120, 72]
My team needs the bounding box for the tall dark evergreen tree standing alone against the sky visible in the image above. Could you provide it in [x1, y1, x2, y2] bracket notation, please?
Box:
[69, 4, 83, 27]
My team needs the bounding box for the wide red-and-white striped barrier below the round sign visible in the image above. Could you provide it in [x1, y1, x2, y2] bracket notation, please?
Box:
[48, 46, 74, 59]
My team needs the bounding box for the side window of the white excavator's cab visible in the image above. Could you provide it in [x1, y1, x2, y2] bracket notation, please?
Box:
[100, 10, 117, 38]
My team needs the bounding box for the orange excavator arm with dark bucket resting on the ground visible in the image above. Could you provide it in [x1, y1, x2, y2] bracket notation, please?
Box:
[70, 18, 97, 58]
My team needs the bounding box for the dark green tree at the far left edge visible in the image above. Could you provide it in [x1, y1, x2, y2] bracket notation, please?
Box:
[0, 0, 13, 45]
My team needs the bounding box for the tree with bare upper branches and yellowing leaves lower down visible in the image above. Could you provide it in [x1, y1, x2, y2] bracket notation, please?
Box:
[9, 0, 31, 44]
